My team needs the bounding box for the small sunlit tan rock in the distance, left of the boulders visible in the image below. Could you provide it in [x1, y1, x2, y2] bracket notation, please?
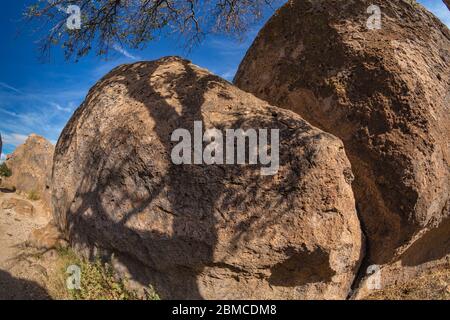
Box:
[2, 134, 54, 209]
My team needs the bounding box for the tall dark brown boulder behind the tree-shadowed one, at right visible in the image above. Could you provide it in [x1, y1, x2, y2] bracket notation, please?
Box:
[235, 0, 450, 264]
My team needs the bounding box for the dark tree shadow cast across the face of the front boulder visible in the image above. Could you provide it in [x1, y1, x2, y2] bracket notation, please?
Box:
[55, 60, 336, 299]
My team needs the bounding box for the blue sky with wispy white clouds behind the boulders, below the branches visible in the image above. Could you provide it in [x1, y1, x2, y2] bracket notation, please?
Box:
[0, 0, 450, 158]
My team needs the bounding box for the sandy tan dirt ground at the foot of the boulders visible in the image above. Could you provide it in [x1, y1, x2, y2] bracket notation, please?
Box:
[0, 191, 450, 300]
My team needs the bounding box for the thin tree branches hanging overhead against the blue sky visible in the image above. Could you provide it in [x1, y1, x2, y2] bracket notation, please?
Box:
[24, 0, 279, 59]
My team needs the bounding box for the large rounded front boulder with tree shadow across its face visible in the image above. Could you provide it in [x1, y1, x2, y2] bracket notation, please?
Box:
[52, 57, 361, 299]
